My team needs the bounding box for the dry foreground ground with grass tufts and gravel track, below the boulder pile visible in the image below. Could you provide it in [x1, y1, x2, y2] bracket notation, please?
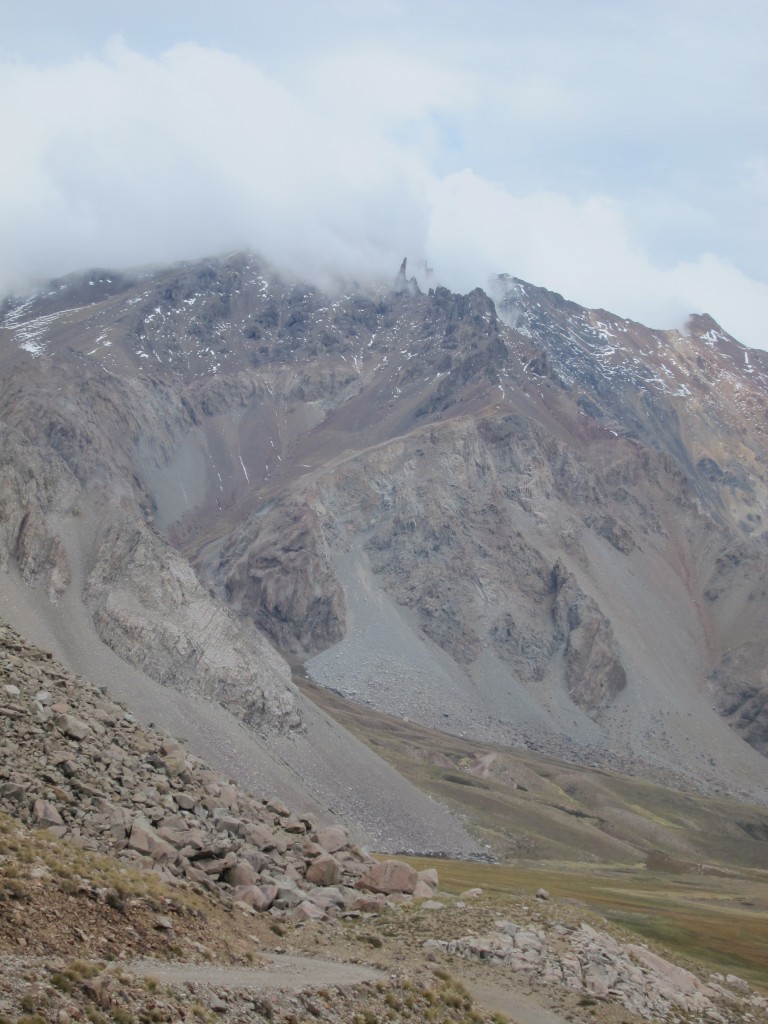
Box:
[0, 817, 768, 1024]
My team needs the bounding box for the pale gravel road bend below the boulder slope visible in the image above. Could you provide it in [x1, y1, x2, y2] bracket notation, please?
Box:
[125, 953, 386, 992]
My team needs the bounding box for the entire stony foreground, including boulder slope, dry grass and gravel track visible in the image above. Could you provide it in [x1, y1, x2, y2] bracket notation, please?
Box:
[0, 614, 768, 1024]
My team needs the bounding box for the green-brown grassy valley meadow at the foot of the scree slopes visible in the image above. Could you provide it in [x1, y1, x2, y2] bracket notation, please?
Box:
[296, 675, 768, 990]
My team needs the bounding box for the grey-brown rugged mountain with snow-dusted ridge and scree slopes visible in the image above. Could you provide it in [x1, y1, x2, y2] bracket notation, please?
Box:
[0, 254, 768, 831]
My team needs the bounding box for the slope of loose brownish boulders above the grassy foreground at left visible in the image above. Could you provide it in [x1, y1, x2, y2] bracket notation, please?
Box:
[0, 625, 437, 920]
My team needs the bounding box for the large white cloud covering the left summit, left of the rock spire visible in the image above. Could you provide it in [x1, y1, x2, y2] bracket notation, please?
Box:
[0, 43, 434, 287]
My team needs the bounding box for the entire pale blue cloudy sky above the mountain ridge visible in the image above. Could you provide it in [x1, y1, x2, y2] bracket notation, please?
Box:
[0, 0, 768, 348]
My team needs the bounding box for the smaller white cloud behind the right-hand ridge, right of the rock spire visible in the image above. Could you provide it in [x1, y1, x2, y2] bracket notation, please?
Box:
[428, 171, 768, 348]
